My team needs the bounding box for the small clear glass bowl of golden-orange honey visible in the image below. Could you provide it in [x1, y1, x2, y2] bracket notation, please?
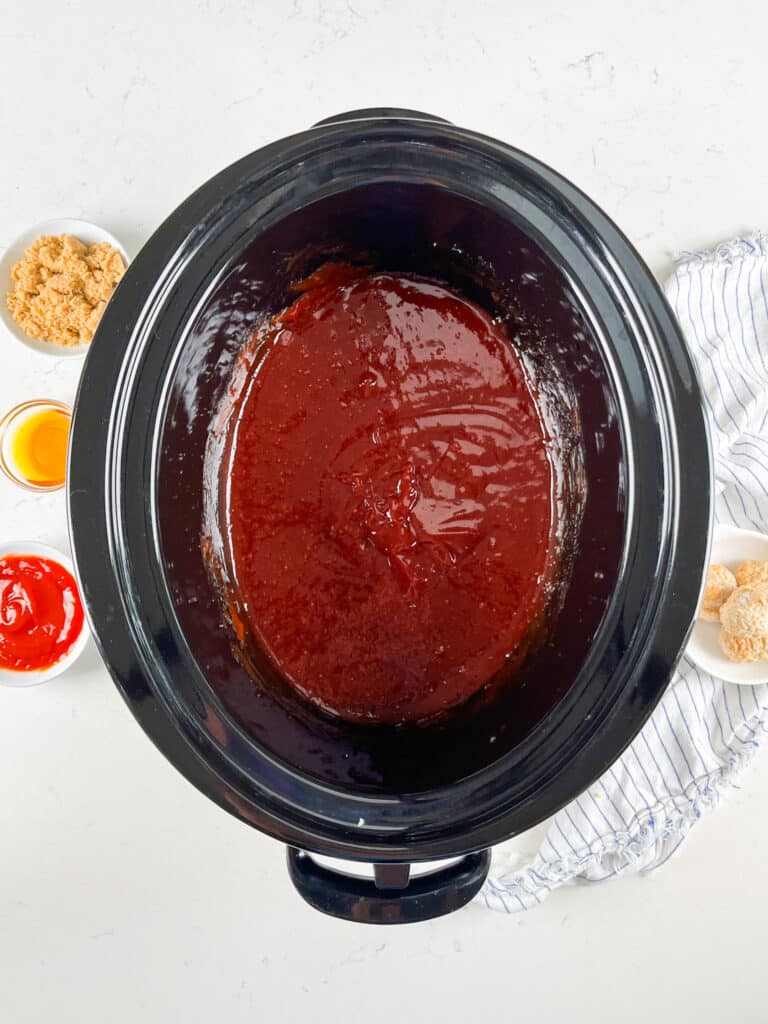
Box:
[0, 398, 72, 492]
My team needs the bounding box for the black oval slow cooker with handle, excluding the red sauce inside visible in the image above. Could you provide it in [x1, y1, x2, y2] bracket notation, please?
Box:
[68, 110, 712, 924]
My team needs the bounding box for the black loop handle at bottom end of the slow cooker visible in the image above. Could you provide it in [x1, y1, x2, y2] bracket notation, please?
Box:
[288, 847, 490, 925]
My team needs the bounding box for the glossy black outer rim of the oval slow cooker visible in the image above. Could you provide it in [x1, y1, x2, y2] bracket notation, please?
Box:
[70, 114, 710, 859]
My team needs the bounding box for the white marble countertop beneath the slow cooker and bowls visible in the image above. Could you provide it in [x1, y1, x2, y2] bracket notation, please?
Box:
[0, 0, 768, 1024]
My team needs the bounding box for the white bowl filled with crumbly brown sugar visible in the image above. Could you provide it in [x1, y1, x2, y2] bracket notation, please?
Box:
[0, 218, 128, 356]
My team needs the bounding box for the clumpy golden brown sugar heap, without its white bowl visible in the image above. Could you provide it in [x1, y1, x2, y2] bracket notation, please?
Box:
[5, 234, 125, 346]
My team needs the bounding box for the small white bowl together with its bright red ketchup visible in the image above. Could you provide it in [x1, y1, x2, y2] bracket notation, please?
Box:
[0, 541, 88, 686]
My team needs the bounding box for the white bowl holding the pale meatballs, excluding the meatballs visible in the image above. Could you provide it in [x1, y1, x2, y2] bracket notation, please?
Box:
[685, 524, 768, 686]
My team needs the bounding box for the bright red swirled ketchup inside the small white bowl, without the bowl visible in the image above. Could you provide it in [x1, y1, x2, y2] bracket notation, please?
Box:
[0, 555, 83, 672]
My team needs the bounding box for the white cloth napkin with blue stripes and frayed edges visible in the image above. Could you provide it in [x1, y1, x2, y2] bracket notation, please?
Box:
[478, 233, 768, 913]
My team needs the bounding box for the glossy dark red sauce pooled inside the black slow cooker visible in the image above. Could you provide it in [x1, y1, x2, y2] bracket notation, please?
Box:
[221, 267, 553, 723]
